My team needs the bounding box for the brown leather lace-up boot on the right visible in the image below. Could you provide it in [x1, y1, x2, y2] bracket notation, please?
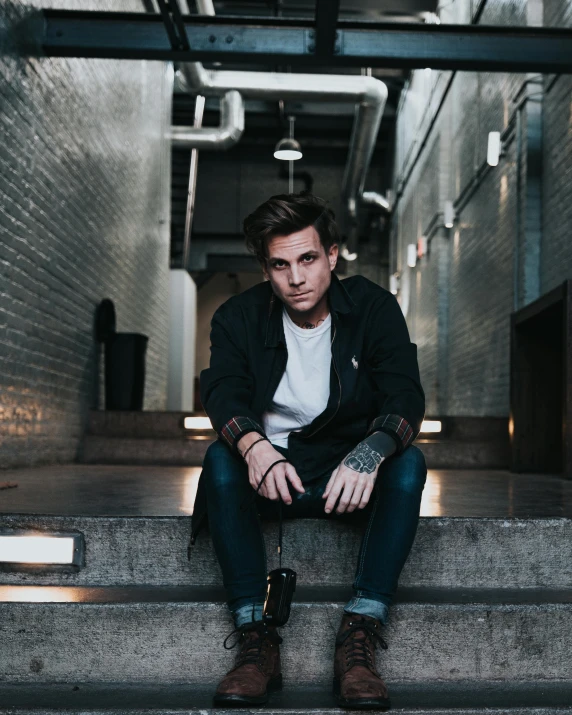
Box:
[334, 613, 391, 710]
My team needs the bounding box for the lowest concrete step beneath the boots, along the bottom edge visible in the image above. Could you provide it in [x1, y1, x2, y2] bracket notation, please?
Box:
[0, 680, 572, 715]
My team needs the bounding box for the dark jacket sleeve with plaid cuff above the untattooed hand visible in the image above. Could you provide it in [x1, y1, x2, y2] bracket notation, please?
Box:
[199, 304, 266, 454]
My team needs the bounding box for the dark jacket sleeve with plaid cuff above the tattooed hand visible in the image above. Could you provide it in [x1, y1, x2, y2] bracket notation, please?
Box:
[366, 293, 425, 454]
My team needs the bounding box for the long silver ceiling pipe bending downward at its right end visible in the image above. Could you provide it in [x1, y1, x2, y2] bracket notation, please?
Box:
[179, 0, 389, 253]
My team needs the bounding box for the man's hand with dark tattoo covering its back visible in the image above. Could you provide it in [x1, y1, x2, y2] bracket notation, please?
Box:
[322, 441, 385, 514]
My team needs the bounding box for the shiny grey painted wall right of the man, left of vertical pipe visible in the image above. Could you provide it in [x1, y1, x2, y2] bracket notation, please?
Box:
[390, 0, 527, 416]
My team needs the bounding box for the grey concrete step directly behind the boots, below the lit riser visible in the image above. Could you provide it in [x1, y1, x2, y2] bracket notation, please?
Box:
[0, 587, 572, 686]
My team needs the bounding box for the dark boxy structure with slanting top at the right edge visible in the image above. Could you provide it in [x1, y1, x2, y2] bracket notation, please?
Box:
[510, 281, 572, 478]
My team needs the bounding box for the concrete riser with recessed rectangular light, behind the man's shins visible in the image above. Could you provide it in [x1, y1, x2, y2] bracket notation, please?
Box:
[0, 514, 572, 588]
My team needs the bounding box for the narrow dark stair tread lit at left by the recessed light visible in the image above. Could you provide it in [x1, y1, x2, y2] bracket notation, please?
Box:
[0, 585, 572, 606]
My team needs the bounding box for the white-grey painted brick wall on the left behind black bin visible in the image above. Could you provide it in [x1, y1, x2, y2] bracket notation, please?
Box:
[0, 0, 172, 467]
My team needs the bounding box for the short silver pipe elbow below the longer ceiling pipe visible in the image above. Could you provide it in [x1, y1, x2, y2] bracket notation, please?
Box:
[168, 90, 244, 151]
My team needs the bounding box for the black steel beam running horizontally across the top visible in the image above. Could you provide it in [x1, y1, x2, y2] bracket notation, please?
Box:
[32, 10, 572, 74]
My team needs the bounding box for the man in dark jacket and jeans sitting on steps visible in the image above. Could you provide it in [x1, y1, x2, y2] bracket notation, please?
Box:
[191, 193, 427, 708]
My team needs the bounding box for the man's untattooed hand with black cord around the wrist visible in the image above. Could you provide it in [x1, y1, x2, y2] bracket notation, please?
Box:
[240, 440, 306, 504]
